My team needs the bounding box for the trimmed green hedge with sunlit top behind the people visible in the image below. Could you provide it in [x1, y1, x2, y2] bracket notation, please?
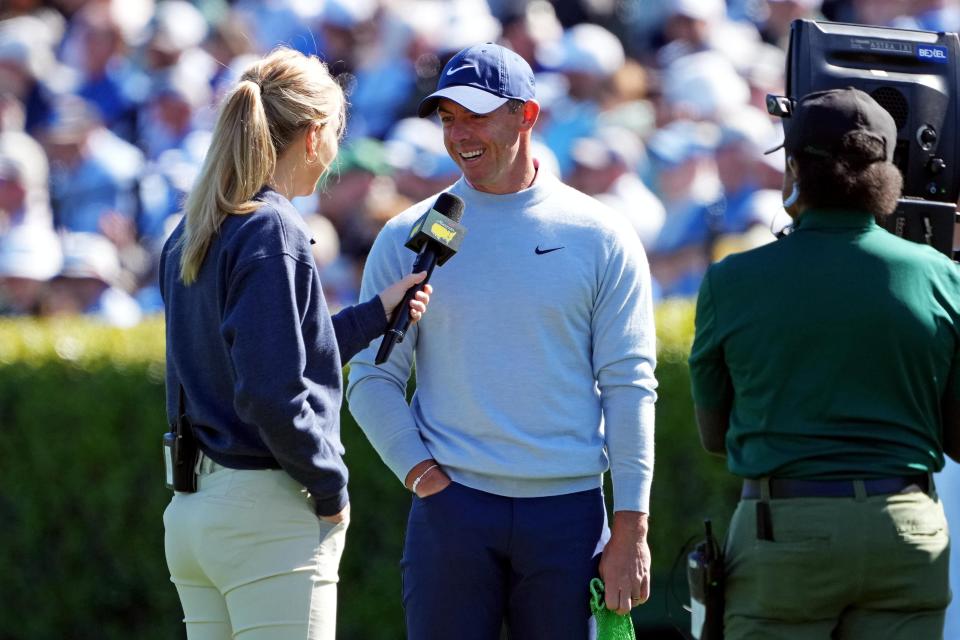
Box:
[0, 304, 736, 640]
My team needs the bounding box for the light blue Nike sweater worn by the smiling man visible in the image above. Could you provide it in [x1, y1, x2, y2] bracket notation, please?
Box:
[347, 172, 656, 512]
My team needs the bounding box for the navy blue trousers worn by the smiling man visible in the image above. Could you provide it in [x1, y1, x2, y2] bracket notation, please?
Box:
[401, 482, 609, 640]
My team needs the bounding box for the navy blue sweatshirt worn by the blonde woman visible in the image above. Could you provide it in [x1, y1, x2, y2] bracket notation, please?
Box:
[160, 189, 387, 515]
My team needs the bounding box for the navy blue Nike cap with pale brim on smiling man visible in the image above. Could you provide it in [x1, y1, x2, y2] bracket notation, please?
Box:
[417, 42, 536, 118]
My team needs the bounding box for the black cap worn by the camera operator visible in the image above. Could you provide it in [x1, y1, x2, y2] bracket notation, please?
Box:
[767, 87, 897, 162]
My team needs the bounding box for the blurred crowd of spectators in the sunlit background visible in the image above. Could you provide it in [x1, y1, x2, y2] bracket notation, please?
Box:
[0, 0, 960, 326]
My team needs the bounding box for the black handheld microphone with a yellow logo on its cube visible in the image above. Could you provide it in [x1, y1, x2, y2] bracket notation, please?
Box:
[374, 193, 467, 364]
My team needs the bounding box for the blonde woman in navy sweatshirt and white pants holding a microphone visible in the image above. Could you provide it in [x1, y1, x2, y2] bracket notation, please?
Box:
[160, 49, 430, 640]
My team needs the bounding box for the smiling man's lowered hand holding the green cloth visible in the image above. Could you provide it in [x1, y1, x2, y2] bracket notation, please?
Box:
[600, 511, 650, 615]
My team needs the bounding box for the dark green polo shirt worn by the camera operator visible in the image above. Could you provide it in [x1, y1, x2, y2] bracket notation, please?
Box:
[690, 210, 960, 479]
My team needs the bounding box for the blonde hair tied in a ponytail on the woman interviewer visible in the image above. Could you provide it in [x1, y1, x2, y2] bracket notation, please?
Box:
[180, 48, 346, 285]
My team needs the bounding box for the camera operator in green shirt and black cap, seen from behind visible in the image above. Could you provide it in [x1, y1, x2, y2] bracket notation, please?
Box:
[690, 88, 960, 640]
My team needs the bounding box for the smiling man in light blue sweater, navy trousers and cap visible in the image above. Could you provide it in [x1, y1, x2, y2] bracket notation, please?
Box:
[348, 44, 656, 640]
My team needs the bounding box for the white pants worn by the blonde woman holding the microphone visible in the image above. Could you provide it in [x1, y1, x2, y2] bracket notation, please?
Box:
[163, 460, 347, 640]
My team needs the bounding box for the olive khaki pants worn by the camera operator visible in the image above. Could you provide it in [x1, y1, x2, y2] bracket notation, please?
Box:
[724, 492, 950, 640]
